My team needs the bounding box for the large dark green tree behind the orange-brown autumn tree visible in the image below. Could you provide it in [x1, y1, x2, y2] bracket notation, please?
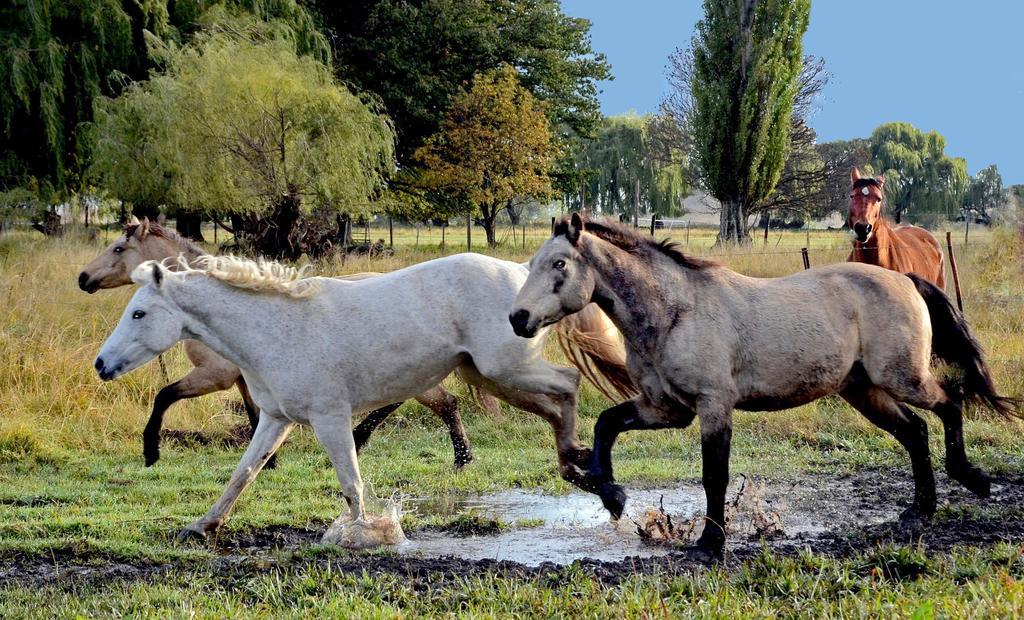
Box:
[310, 0, 610, 167]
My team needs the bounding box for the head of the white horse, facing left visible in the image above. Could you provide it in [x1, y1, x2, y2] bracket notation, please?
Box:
[95, 260, 184, 381]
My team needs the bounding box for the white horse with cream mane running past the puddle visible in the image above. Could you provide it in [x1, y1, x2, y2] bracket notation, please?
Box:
[95, 254, 589, 547]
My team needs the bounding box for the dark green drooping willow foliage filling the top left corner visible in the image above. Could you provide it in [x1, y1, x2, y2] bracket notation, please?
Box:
[0, 0, 170, 202]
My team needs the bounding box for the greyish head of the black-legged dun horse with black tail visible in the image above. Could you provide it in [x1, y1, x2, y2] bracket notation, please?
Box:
[509, 213, 594, 338]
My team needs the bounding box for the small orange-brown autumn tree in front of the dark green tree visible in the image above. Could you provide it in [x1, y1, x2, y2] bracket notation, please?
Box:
[415, 66, 555, 247]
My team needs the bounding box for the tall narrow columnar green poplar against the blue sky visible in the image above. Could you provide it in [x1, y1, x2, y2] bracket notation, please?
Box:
[682, 0, 811, 243]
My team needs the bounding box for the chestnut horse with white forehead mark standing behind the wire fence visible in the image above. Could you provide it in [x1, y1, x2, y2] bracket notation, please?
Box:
[847, 168, 945, 288]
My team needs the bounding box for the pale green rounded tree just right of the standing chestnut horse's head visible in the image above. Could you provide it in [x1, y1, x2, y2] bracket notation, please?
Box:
[871, 123, 970, 222]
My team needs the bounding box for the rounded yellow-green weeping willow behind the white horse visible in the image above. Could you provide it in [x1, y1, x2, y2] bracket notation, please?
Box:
[95, 34, 394, 258]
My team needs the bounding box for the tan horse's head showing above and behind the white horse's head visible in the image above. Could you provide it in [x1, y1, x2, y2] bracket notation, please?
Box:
[78, 217, 181, 293]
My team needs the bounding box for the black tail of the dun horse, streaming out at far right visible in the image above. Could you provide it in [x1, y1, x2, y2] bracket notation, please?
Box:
[906, 274, 1024, 419]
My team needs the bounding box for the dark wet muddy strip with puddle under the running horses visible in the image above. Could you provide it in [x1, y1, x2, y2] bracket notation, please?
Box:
[0, 469, 1024, 588]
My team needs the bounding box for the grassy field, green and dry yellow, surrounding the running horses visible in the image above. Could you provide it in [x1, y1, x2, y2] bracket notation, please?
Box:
[0, 223, 1024, 617]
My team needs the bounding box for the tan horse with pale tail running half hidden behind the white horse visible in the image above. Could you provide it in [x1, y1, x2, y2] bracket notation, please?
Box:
[78, 218, 635, 467]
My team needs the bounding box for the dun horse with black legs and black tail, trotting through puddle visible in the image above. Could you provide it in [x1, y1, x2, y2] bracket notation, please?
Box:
[509, 214, 1020, 555]
